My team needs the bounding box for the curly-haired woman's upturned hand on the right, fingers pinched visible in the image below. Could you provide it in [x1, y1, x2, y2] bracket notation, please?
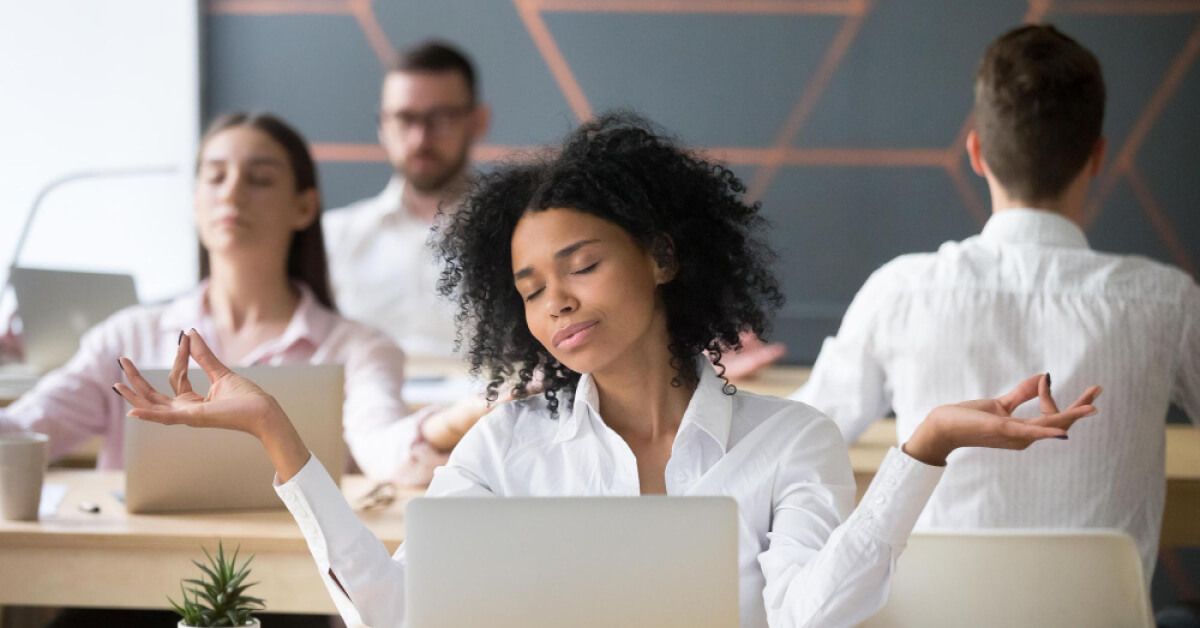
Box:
[902, 373, 1100, 466]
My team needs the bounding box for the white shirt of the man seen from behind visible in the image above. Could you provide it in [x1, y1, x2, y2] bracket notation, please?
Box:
[796, 209, 1200, 581]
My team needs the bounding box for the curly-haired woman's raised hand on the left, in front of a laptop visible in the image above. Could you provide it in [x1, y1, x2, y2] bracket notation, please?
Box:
[113, 329, 308, 482]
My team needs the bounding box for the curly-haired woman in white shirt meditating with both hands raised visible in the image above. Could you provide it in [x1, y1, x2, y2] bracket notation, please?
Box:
[118, 115, 1097, 627]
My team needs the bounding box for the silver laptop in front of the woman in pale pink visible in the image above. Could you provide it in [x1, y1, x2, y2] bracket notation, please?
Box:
[125, 364, 346, 513]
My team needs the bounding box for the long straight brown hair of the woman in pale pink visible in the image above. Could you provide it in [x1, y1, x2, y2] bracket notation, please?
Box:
[197, 112, 337, 311]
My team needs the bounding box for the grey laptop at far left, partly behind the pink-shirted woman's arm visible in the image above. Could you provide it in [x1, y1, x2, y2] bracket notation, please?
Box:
[10, 268, 138, 372]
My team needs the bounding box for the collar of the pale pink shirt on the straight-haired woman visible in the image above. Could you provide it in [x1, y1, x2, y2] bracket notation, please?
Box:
[158, 280, 336, 364]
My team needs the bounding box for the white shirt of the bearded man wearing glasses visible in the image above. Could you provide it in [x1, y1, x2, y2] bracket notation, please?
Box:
[322, 178, 455, 357]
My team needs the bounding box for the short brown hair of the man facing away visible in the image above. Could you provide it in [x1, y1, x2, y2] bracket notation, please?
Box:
[974, 24, 1105, 202]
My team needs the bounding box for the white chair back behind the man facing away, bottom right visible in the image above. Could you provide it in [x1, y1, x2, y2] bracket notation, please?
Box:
[863, 530, 1154, 628]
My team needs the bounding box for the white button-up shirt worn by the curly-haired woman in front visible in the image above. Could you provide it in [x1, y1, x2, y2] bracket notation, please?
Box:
[276, 364, 942, 628]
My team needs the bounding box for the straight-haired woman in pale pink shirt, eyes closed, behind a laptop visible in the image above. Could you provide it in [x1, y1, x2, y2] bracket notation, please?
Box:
[0, 113, 485, 485]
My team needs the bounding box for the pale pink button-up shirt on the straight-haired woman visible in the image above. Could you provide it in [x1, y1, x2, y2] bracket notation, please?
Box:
[0, 281, 432, 478]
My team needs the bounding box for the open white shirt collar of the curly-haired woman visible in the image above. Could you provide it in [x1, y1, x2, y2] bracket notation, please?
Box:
[554, 355, 733, 453]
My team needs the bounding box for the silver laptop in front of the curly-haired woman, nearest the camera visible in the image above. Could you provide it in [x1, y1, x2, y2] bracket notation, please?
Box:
[404, 497, 738, 628]
